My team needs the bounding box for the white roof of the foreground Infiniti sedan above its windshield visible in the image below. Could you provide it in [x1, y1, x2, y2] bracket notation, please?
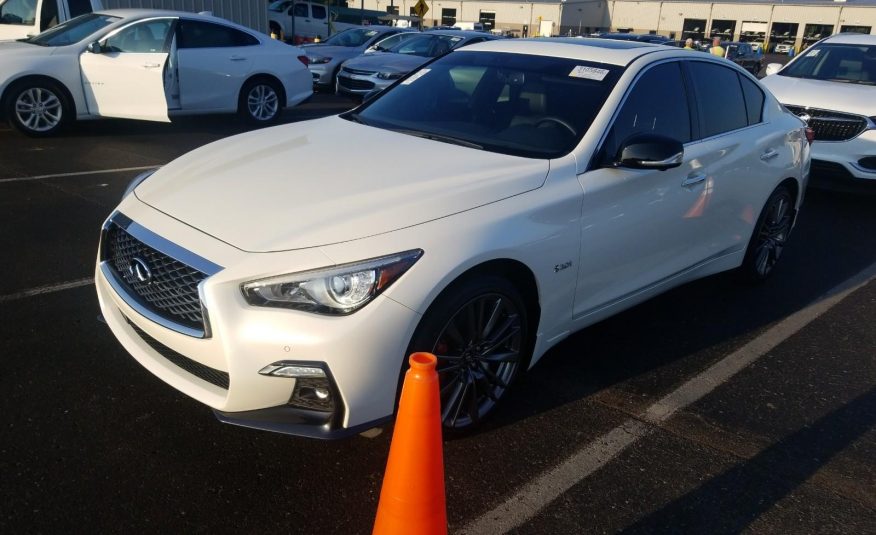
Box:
[454, 37, 668, 65]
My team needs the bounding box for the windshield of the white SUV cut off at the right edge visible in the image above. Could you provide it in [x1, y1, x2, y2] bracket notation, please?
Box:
[779, 43, 876, 85]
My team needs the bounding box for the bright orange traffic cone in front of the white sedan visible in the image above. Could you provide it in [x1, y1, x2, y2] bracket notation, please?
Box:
[374, 353, 447, 535]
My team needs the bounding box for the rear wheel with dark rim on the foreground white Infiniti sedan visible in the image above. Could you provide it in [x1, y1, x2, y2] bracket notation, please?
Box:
[739, 186, 794, 282]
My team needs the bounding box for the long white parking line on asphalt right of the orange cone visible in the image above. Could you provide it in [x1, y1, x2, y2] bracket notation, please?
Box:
[460, 264, 876, 535]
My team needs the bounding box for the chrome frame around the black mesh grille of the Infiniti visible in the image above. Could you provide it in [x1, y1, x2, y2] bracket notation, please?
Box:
[100, 211, 223, 339]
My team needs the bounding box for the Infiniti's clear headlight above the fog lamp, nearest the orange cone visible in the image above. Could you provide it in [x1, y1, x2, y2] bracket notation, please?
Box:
[240, 249, 423, 315]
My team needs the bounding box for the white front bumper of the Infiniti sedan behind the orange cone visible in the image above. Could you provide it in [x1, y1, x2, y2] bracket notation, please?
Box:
[95, 203, 419, 438]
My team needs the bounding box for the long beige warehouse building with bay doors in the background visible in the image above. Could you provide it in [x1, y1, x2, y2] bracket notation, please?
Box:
[351, 0, 876, 51]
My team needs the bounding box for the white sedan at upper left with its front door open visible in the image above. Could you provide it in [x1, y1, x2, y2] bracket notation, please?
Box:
[0, 9, 312, 136]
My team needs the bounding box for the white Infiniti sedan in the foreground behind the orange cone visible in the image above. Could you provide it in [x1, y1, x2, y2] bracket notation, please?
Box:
[95, 39, 809, 437]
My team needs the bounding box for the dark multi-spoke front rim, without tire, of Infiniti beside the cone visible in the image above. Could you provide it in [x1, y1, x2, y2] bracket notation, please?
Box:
[432, 294, 523, 429]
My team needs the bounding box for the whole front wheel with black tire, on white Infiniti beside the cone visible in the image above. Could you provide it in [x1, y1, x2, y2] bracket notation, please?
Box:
[403, 276, 532, 433]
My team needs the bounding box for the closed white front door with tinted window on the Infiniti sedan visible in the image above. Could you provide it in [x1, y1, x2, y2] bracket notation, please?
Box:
[575, 62, 708, 319]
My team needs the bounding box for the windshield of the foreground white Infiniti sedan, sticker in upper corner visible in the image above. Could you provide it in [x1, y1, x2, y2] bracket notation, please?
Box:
[343, 52, 622, 158]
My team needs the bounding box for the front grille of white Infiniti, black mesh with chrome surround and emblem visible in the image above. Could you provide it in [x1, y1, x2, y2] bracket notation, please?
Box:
[100, 212, 222, 338]
